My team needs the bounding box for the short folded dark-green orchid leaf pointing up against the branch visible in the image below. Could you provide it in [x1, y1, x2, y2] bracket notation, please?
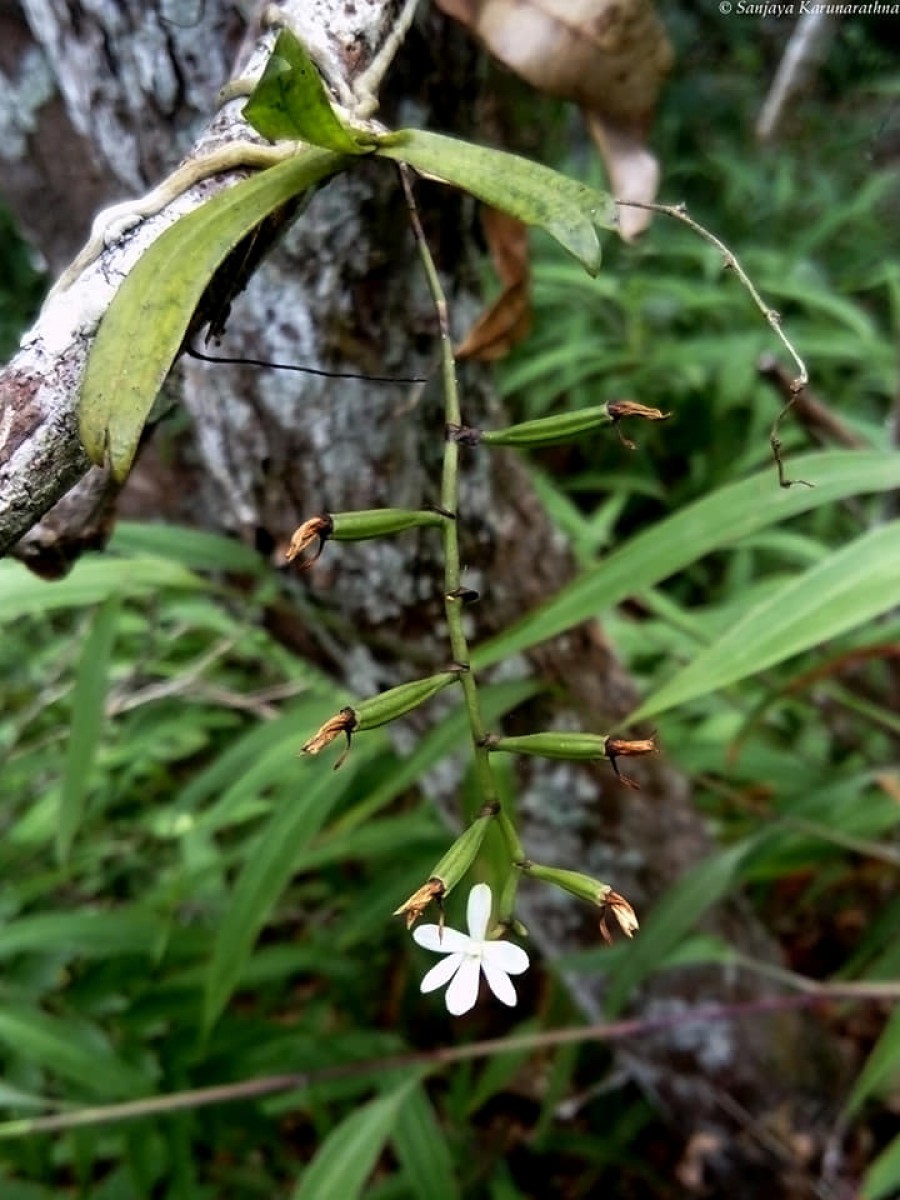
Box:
[244, 29, 374, 154]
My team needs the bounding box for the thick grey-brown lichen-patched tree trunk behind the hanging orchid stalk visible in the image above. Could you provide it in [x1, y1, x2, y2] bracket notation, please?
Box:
[0, 0, 844, 1180]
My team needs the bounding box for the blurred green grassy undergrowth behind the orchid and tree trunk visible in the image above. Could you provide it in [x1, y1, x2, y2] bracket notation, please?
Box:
[0, 11, 900, 1200]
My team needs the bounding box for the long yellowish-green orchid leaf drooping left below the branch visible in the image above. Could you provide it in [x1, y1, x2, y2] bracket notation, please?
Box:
[79, 146, 348, 480]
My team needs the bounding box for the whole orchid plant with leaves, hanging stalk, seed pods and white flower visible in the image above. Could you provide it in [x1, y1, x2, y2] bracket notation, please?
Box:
[72, 6, 806, 1013]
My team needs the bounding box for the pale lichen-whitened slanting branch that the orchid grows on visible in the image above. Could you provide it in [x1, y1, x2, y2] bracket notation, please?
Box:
[0, 0, 413, 557]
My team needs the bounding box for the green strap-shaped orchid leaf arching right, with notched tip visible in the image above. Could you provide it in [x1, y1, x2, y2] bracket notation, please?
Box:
[377, 130, 616, 275]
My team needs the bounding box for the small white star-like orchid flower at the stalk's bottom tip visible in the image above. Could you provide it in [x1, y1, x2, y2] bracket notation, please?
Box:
[413, 883, 528, 1016]
